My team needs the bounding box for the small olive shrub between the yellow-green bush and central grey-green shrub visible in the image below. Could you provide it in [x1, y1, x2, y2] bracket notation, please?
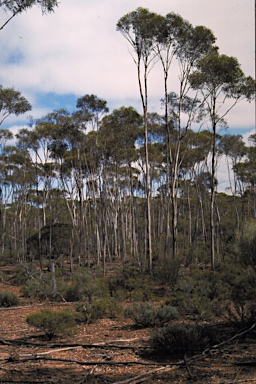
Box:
[76, 297, 121, 324]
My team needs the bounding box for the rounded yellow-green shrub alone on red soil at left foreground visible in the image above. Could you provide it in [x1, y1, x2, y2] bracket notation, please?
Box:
[26, 309, 76, 340]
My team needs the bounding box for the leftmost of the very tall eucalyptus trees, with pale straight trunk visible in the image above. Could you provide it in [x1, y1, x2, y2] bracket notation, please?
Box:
[117, 8, 158, 273]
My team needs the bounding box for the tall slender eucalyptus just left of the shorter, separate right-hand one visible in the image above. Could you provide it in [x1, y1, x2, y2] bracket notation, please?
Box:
[166, 24, 216, 258]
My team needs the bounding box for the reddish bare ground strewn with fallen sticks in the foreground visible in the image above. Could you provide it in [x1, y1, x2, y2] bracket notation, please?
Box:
[0, 283, 256, 384]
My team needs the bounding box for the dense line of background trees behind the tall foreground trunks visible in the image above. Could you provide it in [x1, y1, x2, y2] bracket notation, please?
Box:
[0, 95, 256, 271]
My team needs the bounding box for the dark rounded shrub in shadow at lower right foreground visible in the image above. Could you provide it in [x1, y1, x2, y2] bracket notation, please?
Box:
[152, 324, 211, 357]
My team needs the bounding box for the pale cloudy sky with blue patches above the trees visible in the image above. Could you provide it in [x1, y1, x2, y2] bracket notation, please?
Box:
[0, 0, 255, 138]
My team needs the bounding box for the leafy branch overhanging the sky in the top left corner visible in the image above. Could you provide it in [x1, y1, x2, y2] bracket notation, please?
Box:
[0, 0, 59, 30]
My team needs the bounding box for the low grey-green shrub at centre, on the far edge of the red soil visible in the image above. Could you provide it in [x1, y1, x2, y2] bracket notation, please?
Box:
[124, 303, 179, 327]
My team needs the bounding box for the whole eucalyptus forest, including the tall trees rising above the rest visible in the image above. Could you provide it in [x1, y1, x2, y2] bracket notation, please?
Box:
[0, 8, 256, 275]
